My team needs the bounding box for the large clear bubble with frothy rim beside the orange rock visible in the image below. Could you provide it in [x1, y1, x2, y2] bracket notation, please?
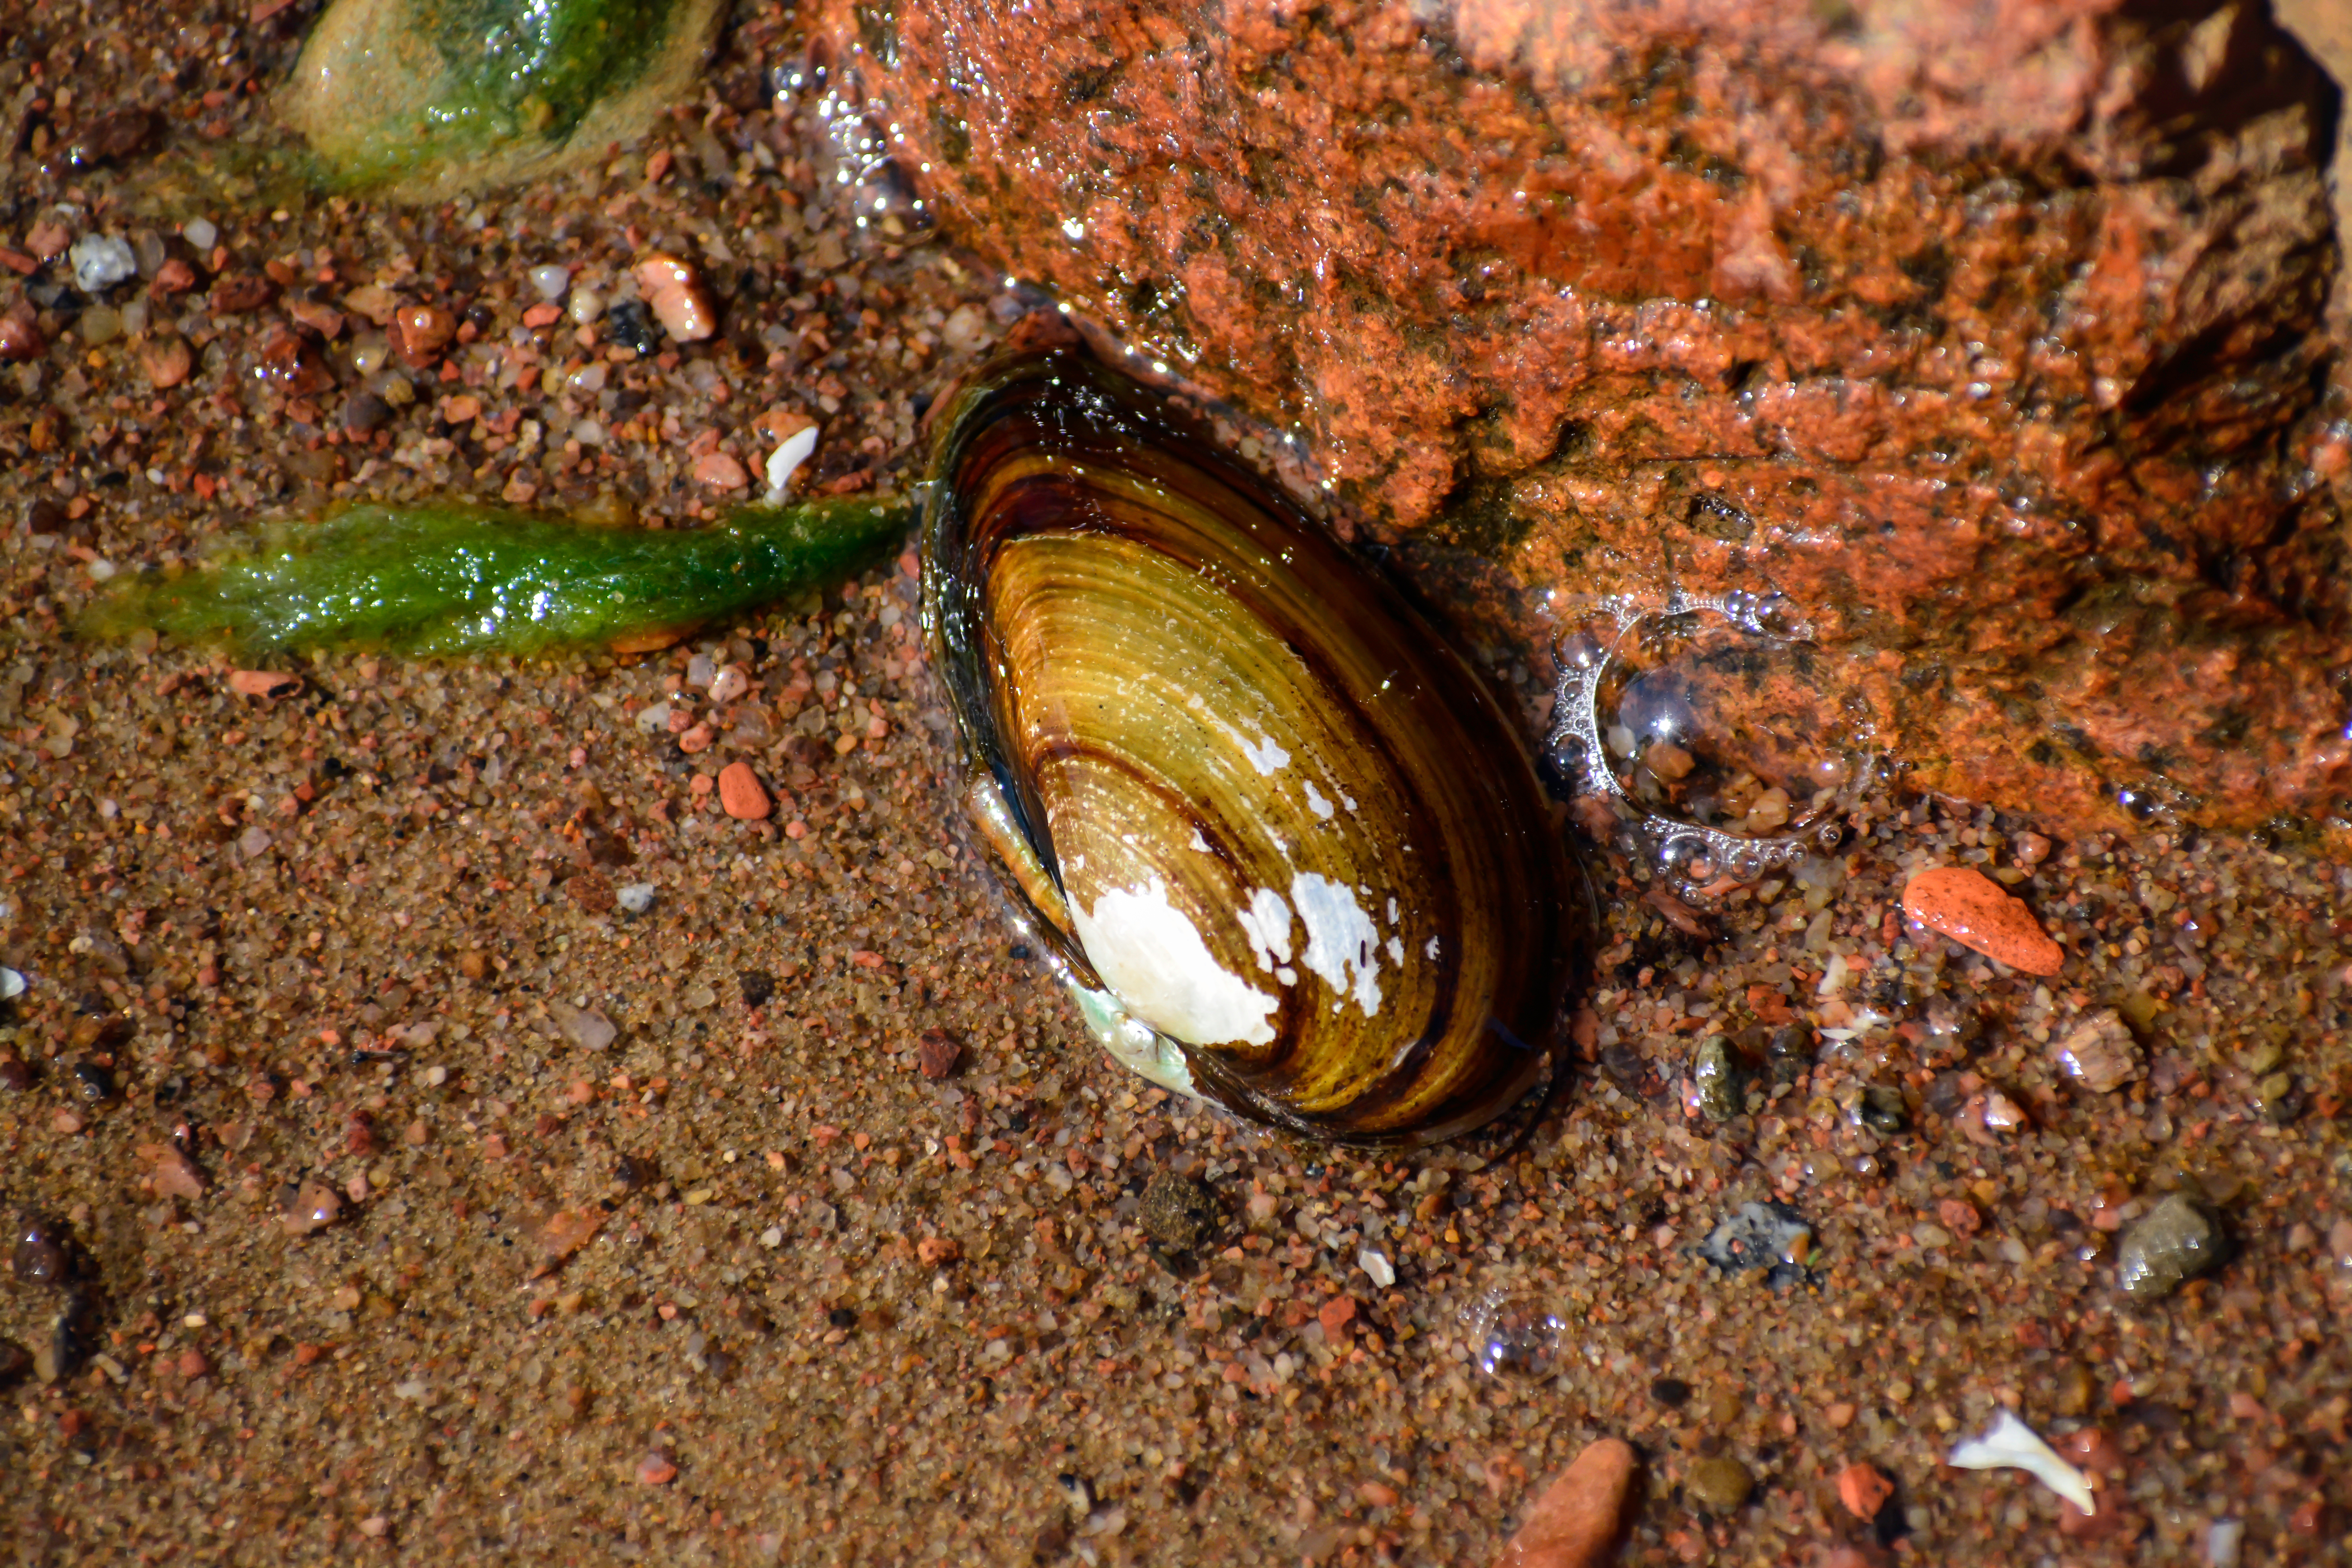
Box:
[1545, 592, 1879, 905]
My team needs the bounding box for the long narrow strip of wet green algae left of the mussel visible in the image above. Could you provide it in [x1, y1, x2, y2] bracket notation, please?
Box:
[87, 498, 913, 656]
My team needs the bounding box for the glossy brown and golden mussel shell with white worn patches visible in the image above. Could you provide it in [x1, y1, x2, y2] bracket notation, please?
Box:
[924, 350, 1581, 1145]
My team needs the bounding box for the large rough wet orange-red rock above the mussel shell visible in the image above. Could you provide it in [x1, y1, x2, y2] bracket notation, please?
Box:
[818, 0, 2352, 823]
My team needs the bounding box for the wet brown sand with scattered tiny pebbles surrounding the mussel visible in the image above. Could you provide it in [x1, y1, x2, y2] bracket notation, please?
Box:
[0, 7, 2352, 1563]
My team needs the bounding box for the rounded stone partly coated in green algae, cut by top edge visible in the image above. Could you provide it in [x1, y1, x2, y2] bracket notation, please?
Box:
[278, 0, 720, 200]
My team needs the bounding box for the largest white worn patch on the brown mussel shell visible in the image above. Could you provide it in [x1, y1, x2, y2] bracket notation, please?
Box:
[1070, 877, 1275, 1046]
